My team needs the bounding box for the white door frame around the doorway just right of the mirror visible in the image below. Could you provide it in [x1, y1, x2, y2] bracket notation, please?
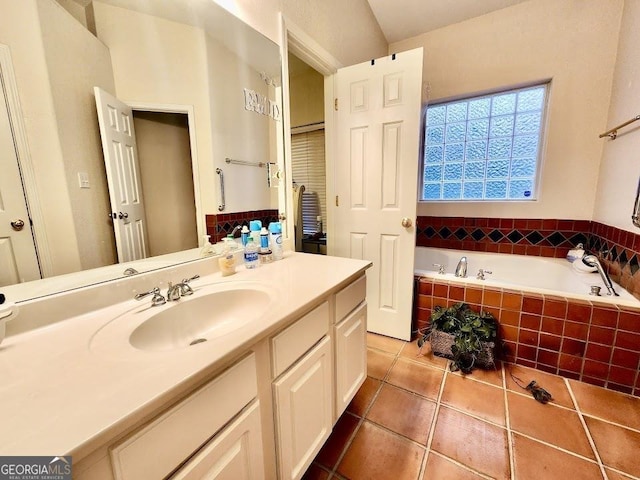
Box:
[280, 14, 343, 255]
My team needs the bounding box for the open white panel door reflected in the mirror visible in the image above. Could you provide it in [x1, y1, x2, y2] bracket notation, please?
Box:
[94, 87, 148, 262]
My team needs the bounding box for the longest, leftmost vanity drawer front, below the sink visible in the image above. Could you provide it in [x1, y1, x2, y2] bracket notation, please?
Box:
[111, 354, 257, 480]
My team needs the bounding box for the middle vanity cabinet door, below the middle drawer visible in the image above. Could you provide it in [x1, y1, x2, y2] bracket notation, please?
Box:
[273, 337, 333, 480]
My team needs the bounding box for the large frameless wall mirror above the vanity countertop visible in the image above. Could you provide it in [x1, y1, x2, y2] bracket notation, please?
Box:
[0, 0, 286, 301]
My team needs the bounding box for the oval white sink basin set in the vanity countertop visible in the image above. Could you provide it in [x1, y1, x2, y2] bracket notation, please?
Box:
[129, 288, 271, 350]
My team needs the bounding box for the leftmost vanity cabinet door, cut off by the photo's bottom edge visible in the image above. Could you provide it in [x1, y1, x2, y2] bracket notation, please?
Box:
[171, 401, 264, 480]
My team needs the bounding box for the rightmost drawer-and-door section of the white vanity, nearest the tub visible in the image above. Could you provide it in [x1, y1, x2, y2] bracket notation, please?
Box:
[333, 276, 367, 422]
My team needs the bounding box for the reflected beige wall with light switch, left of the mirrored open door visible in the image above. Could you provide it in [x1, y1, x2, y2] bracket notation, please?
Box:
[38, 0, 117, 270]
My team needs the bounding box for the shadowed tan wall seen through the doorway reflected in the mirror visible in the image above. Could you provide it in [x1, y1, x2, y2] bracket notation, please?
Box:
[133, 112, 198, 257]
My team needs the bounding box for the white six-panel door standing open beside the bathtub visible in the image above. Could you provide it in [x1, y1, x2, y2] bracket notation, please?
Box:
[334, 48, 422, 340]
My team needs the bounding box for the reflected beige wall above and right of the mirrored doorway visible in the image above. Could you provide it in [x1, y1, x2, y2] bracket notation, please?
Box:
[94, 2, 217, 213]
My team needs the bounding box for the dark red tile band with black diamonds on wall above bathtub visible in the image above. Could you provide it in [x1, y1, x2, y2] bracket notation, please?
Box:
[416, 216, 640, 298]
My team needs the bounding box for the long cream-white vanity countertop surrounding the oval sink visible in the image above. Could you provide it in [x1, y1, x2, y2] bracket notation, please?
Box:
[0, 253, 370, 461]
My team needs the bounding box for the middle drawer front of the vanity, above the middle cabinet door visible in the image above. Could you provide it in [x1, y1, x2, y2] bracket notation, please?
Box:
[271, 302, 329, 377]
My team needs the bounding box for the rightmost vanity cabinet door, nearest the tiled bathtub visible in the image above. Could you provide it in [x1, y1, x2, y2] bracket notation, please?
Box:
[335, 303, 367, 420]
